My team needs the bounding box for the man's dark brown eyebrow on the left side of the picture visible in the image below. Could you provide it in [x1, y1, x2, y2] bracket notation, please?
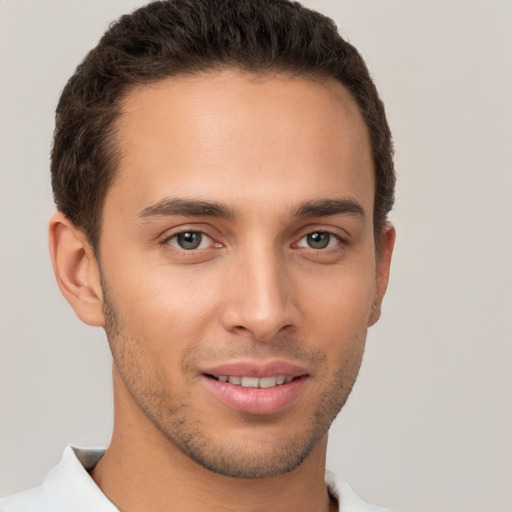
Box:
[139, 198, 236, 219]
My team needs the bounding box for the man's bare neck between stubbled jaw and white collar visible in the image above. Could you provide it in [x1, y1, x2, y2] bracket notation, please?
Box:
[92, 370, 336, 512]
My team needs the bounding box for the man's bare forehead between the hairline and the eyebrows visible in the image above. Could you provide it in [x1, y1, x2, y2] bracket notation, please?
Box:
[106, 70, 374, 215]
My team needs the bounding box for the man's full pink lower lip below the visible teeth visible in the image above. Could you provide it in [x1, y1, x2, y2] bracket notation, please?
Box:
[203, 375, 308, 414]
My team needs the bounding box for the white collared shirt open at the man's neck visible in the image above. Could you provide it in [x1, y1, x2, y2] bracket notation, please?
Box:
[0, 446, 390, 512]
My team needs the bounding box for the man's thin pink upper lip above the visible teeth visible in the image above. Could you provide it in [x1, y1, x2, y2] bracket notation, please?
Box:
[200, 360, 308, 378]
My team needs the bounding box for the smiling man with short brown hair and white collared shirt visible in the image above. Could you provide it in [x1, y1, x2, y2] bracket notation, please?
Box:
[0, 0, 394, 512]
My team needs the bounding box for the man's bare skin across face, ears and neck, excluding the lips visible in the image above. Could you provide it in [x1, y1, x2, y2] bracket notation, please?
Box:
[50, 70, 394, 512]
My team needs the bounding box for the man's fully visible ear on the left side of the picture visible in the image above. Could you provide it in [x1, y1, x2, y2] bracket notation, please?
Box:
[48, 212, 104, 327]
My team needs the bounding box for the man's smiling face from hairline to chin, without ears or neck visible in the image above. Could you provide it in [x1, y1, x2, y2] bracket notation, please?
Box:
[100, 71, 392, 477]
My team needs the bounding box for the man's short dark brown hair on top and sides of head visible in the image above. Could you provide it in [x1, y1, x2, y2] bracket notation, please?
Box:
[51, 0, 395, 251]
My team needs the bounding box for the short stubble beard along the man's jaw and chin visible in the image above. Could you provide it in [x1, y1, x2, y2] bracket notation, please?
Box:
[103, 286, 364, 479]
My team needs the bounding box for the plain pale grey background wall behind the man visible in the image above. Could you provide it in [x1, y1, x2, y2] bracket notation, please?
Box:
[0, 0, 512, 512]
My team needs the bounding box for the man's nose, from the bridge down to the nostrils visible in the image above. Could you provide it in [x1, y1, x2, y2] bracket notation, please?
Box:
[222, 243, 299, 342]
